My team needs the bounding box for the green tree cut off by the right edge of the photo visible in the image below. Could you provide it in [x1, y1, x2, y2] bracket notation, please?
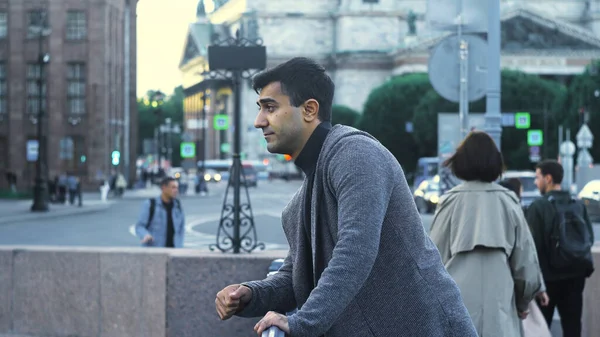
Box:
[563, 61, 600, 161]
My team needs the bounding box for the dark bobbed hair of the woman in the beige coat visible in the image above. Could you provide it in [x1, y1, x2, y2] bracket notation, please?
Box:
[444, 131, 504, 183]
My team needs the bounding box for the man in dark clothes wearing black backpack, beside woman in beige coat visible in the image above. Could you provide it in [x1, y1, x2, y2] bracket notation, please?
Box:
[527, 160, 594, 337]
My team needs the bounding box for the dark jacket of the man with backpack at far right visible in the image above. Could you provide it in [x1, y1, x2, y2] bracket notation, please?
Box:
[526, 191, 594, 282]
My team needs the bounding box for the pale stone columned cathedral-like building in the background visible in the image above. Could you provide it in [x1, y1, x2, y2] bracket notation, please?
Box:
[182, 0, 600, 158]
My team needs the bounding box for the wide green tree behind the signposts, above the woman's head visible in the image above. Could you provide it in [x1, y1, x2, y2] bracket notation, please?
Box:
[413, 71, 567, 169]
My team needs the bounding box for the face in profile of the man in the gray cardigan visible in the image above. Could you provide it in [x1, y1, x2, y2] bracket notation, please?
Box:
[254, 82, 304, 154]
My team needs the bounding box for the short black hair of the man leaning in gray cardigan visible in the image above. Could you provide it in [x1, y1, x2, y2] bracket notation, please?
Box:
[252, 57, 335, 122]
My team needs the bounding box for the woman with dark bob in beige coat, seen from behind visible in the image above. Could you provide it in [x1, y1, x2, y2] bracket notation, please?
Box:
[430, 132, 542, 337]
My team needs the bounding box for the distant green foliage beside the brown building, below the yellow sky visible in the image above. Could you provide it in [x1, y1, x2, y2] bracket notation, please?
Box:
[137, 86, 184, 166]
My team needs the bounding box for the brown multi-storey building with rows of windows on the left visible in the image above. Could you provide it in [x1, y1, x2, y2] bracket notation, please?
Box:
[0, 0, 137, 188]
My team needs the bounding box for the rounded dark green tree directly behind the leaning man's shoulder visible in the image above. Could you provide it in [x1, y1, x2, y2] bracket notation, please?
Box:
[359, 74, 431, 178]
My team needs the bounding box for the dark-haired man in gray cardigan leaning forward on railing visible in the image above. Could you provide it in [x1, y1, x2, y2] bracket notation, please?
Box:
[215, 58, 477, 337]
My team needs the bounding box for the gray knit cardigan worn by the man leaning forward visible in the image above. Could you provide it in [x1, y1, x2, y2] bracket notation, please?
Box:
[238, 125, 477, 337]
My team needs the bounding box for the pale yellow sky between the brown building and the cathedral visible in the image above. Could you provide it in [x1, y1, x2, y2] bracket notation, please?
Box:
[137, 0, 198, 97]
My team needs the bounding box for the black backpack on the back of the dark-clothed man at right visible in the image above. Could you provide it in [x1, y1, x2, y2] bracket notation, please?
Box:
[548, 196, 594, 276]
